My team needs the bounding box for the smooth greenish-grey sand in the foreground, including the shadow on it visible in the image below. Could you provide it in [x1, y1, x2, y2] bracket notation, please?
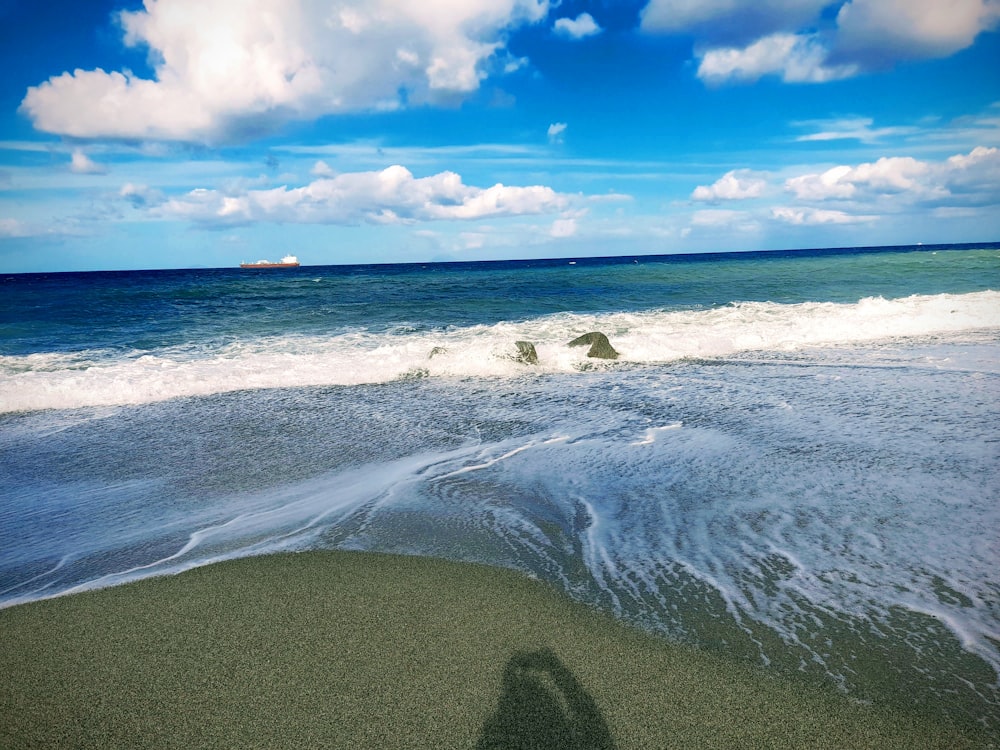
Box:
[0, 552, 987, 750]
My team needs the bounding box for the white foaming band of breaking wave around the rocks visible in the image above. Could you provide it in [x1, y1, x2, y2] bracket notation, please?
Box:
[0, 291, 1000, 413]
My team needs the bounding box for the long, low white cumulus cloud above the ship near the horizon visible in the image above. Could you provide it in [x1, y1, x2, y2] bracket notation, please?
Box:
[155, 165, 568, 226]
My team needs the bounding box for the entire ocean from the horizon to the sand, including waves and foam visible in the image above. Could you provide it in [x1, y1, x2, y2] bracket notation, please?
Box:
[0, 243, 1000, 734]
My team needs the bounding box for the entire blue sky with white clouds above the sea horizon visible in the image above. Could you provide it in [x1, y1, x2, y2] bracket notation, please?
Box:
[0, 0, 1000, 273]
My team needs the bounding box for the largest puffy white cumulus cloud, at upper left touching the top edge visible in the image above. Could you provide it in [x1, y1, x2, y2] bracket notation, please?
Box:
[21, 0, 549, 141]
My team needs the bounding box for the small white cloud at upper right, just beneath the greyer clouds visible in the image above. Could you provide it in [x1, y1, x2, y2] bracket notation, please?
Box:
[698, 33, 858, 84]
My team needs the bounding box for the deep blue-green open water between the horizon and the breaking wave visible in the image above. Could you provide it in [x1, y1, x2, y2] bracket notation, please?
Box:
[0, 244, 1000, 355]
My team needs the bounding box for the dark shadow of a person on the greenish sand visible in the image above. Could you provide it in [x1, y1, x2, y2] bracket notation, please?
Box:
[476, 648, 615, 750]
